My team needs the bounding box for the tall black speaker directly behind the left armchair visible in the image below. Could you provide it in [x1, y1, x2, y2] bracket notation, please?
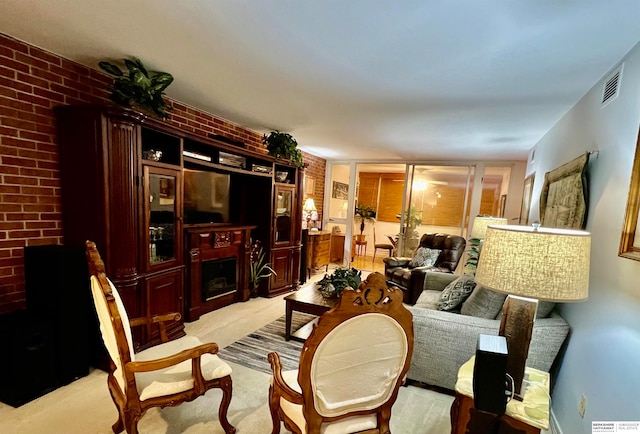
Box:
[24, 245, 93, 385]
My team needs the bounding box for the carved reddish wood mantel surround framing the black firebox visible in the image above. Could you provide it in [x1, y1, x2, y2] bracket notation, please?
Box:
[185, 225, 256, 321]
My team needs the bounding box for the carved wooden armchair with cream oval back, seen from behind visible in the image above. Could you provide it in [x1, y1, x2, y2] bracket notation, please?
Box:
[268, 273, 413, 434]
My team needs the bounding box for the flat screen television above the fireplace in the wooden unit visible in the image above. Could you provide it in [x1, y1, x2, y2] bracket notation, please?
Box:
[184, 169, 231, 224]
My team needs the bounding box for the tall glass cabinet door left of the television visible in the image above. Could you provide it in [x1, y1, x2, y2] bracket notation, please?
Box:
[145, 167, 179, 267]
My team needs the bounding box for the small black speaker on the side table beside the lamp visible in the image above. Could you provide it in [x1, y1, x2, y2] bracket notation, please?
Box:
[473, 334, 509, 414]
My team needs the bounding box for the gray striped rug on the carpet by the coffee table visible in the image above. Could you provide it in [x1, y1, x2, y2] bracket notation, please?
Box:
[218, 312, 317, 374]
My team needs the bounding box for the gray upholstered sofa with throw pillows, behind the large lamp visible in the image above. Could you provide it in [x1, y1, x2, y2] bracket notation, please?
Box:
[407, 272, 570, 390]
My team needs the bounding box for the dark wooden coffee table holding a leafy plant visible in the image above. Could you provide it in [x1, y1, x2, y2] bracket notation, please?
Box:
[284, 283, 338, 342]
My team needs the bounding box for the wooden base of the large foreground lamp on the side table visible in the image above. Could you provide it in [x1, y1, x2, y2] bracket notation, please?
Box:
[498, 295, 538, 401]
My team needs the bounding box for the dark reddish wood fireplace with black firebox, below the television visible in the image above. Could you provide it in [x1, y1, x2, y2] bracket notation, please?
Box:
[185, 225, 255, 321]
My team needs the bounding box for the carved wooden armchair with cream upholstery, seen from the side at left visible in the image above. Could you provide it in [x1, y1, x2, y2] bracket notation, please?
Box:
[86, 241, 236, 434]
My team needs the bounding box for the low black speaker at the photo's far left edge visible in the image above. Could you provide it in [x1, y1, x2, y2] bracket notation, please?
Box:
[0, 311, 58, 407]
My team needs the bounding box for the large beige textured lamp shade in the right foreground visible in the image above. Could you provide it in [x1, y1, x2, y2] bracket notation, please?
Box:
[476, 225, 591, 302]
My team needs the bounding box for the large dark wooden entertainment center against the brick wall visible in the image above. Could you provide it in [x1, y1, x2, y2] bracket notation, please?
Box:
[56, 105, 303, 348]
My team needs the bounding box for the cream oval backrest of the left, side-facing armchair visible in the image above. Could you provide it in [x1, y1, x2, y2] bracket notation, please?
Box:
[86, 241, 135, 392]
